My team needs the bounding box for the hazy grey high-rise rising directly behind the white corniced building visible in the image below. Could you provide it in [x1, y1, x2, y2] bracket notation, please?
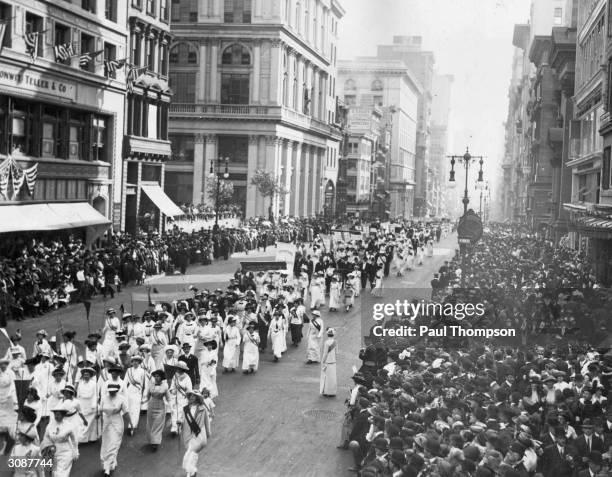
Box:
[377, 36, 435, 217]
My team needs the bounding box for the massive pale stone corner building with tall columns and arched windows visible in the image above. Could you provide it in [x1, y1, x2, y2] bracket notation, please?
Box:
[165, 0, 344, 217]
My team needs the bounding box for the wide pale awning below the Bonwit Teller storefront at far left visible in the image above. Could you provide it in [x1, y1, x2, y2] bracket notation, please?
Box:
[0, 202, 111, 233]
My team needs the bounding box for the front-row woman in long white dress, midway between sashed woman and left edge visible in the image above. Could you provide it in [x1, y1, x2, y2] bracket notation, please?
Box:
[100, 383, 133, 477]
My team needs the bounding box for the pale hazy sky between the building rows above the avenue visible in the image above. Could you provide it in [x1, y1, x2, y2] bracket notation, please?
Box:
[338, 0, 530, 189]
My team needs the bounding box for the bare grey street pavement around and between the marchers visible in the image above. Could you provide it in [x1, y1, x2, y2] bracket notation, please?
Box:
[3, 235, 456, 477]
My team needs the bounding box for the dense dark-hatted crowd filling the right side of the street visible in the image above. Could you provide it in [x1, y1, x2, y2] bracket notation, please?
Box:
[339, 226, 612, 477]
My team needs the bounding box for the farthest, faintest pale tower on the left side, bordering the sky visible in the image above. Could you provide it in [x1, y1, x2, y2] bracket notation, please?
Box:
[429, 75, 454, 217]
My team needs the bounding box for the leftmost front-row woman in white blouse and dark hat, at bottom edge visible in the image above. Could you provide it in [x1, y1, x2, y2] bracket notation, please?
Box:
[40, 403, 79, 477]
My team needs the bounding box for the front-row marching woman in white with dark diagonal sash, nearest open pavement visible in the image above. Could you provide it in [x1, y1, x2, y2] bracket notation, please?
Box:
[181, 391, 211, 477]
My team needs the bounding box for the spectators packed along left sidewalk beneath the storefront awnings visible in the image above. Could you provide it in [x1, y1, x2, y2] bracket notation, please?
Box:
[0, 219, 334, 319]
